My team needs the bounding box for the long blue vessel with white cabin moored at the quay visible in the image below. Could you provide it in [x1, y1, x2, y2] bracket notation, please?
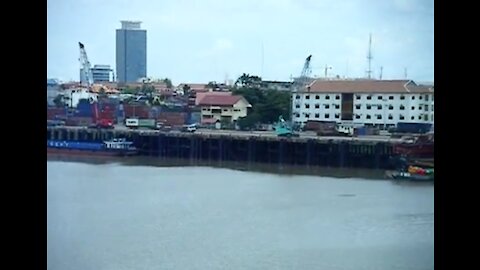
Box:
[47, 138, 138, 156]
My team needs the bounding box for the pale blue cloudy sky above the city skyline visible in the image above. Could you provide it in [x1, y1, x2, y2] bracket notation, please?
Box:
[47, 0, 434, 85]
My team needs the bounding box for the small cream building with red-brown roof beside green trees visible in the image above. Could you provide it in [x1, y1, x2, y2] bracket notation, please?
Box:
[198, 95, 252, 124]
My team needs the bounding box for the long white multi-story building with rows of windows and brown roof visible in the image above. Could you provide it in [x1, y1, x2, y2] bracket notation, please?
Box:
[292, 80, 434, 127]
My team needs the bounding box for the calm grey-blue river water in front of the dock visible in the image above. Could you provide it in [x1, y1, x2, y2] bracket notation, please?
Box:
[47, 160, 434, 270]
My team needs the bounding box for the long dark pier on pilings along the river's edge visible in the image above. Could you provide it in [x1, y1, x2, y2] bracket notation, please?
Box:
[47, 127, 400, 169]
